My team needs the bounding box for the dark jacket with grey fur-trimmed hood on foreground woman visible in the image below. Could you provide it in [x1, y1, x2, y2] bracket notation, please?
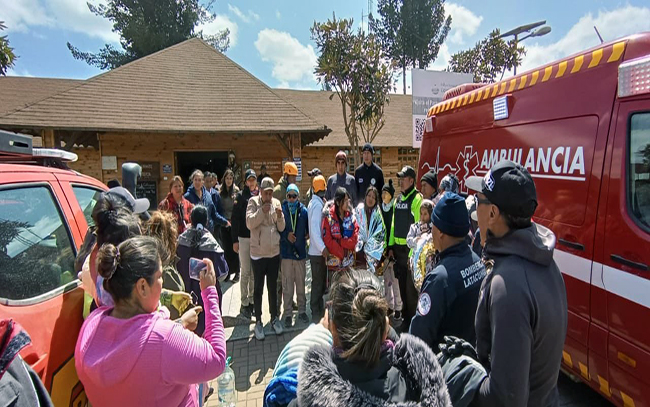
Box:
[290, 334, 451, 407]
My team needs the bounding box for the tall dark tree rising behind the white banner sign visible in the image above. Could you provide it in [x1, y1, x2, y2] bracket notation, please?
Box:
[369, 0, 451, 94]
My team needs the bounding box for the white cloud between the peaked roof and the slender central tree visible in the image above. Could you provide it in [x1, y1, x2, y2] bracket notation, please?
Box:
[255, 28, 318, 87]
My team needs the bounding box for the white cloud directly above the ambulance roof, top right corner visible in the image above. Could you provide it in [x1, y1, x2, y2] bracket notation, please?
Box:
[519, 5, 650, 72]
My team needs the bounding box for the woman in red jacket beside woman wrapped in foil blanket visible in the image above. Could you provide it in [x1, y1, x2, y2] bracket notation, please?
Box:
[321, 187, 359, 271]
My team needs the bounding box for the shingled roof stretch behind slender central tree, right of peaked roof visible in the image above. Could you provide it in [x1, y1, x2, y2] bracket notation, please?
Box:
[274, 89, 413, 147]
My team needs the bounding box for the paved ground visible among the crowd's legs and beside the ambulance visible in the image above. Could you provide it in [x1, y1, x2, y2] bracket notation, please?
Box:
[207, 262, 612, 407]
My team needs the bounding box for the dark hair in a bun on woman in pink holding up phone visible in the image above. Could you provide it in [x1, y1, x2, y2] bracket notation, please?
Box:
[97, 236, 161, 302]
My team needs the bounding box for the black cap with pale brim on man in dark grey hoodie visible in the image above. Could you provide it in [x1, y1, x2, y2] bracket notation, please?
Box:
[465, 160, 537, 218]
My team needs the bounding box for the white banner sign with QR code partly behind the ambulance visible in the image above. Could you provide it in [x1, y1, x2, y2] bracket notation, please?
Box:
[411, 69, 474, 148]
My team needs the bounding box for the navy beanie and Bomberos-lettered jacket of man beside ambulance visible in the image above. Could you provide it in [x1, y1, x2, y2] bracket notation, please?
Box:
[410, 193, 485, 353]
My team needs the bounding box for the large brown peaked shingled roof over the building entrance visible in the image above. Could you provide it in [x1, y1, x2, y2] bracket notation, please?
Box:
[0, 38, 329, 143]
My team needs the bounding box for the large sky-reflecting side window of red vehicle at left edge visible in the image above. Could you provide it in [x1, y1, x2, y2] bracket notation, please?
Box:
[0, 186, 76, 300]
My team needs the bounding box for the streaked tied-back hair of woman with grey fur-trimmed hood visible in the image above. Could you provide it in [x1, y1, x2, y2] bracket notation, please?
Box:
[329, 269, 388, 366]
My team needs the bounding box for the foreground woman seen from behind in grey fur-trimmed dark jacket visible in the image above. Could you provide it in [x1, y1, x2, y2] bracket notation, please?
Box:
[289, 269, 451, 407]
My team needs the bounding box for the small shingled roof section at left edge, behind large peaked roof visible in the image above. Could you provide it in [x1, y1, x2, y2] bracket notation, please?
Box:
[0, 76, 83, 116]
